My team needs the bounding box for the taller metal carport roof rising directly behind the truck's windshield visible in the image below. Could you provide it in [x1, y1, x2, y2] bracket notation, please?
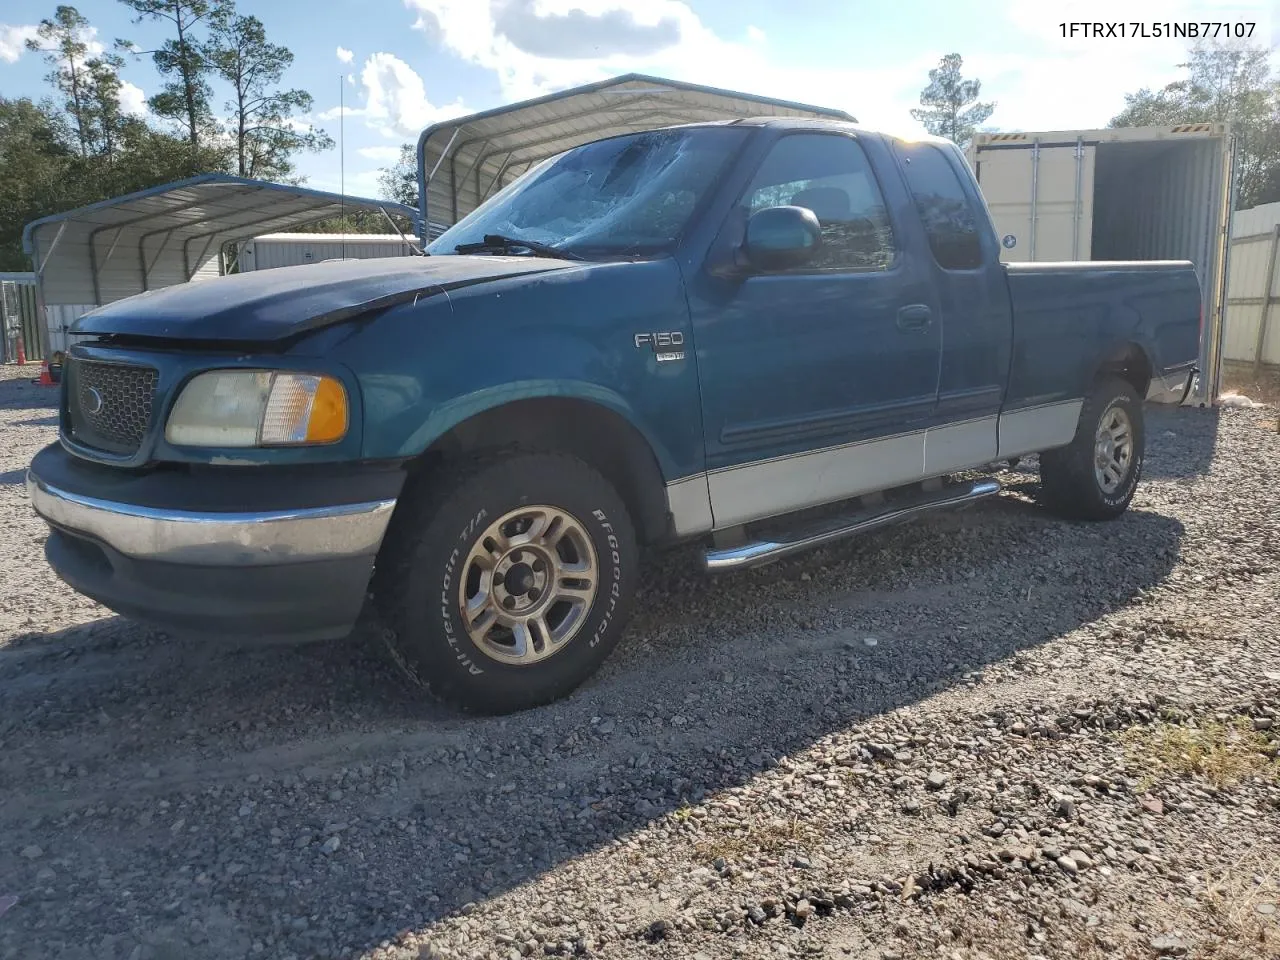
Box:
[417, 73, 854, 238]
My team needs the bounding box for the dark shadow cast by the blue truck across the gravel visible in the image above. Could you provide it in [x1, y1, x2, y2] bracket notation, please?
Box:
[0, 491, 1184, 956]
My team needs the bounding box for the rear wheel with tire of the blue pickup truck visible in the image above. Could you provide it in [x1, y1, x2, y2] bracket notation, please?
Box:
[1039, 376, 1146, 520]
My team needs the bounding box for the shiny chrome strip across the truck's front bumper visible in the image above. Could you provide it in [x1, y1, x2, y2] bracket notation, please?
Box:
[27, 471, 396, 567]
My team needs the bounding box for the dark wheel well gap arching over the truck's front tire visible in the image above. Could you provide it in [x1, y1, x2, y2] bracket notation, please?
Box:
[411, 397, 669, 543]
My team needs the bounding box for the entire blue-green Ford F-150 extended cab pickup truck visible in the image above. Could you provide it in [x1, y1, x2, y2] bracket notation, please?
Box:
[27, 119, 1202, 712]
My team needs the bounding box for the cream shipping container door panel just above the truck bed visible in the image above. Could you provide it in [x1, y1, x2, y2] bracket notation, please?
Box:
[977, 143, 1094, 262]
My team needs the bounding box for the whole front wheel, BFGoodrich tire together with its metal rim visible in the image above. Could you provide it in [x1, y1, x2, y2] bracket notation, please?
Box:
[375, 453, 639, 713]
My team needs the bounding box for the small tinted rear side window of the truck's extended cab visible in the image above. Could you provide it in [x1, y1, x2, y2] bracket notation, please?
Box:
[896, 143, 982, 270]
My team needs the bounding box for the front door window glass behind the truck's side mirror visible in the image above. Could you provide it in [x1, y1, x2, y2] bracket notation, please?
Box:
[744, 133, 893, 270]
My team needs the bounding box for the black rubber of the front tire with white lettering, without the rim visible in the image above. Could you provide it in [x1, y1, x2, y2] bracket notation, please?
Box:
[374, 451, 639, 714]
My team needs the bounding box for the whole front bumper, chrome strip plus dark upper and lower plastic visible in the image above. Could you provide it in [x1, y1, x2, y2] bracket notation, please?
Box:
[27, 444, 403, 640]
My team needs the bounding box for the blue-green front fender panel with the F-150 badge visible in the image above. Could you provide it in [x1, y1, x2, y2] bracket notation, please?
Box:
[340, 259, 704, 480]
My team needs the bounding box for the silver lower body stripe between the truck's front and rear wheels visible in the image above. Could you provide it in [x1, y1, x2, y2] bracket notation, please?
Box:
[667, 399, 1083, 536]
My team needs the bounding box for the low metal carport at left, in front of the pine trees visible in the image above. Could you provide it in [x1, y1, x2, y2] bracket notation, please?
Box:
[22, 173, 420, 352]
